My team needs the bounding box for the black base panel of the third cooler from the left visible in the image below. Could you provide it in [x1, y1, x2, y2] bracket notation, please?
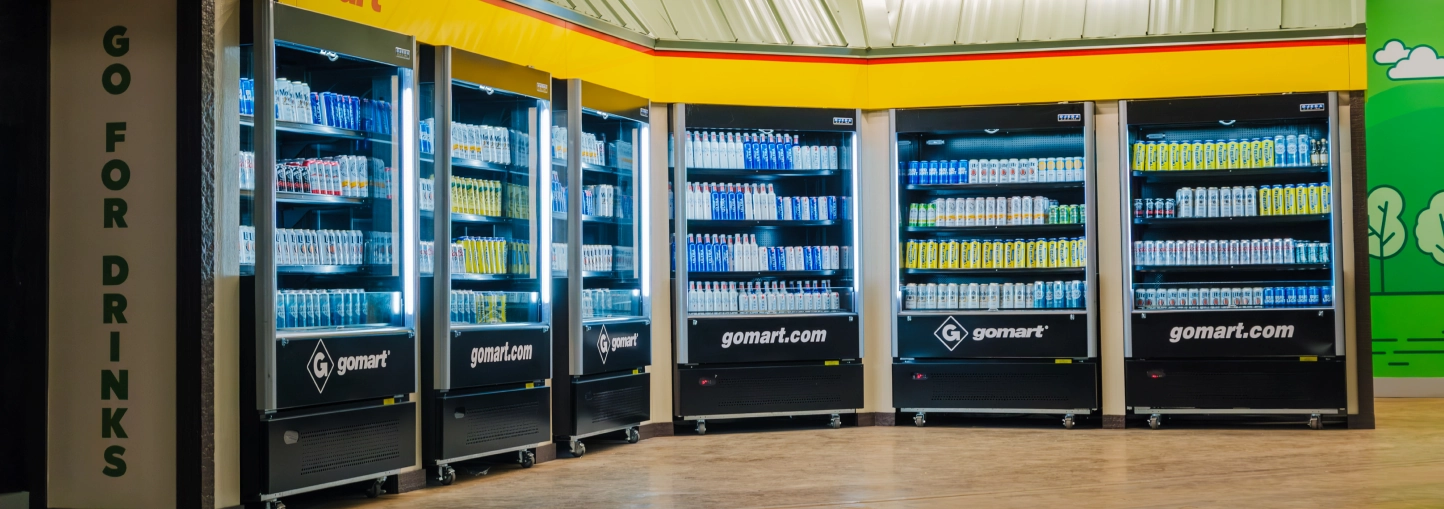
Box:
[556, 372, 651, 438]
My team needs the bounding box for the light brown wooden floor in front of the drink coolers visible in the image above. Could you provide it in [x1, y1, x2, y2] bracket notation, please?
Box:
[290, 399, 1444, 509]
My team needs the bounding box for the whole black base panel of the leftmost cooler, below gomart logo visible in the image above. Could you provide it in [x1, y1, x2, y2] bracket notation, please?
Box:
[243, 402, 416, 495]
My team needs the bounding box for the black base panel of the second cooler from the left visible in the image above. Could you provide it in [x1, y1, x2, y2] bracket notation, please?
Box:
[422, 386, 552, 464]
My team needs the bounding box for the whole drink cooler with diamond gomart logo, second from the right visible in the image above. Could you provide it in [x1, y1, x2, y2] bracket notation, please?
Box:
[891, 103, 1099, 428]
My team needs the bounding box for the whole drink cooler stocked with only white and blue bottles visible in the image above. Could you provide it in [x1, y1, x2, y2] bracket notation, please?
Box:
[671, 104, 862, 434]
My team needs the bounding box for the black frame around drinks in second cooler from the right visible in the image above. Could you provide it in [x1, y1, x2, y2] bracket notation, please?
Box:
[888, 103, 1100, 427]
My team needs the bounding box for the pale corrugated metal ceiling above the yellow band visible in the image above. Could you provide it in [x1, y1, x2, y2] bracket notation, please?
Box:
[531, 0, 1365, 51]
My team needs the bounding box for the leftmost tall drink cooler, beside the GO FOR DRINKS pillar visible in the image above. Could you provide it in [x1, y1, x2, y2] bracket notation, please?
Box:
[240, 1, 417, 508]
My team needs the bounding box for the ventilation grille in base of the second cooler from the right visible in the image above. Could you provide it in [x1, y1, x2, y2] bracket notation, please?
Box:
[927, 373, 1069, 402]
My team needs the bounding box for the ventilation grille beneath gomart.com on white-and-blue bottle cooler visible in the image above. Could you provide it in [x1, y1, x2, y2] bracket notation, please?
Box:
[709, 375, 845, 408]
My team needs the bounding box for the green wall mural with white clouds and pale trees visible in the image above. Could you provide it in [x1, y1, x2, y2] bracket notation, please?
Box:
[1365, 0, 1444, 377]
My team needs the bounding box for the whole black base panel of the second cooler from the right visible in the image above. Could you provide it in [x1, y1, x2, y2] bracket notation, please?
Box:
[892, 362, 1099, 411]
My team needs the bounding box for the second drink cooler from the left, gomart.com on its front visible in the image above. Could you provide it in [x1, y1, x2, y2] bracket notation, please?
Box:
[419, 45, 552, 484]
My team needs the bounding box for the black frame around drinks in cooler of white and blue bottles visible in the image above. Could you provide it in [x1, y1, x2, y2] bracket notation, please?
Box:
[670, 104, 864, 432]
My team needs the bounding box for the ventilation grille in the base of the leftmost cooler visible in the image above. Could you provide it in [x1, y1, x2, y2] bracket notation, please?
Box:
[299, 421, 410, 476]
